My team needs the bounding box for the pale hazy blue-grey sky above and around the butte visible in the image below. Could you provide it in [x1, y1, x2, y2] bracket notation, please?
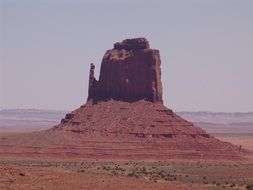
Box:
[0, 0, 253, 112]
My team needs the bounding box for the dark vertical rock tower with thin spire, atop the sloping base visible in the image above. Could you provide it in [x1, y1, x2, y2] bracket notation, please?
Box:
[88, 38, 162, 102]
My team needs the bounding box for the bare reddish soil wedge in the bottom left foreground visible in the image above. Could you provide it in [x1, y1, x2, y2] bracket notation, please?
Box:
[0, 164, 201, 190]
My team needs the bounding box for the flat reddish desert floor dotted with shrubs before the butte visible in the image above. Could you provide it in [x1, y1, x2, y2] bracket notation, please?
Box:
[0, 134, 253, 190]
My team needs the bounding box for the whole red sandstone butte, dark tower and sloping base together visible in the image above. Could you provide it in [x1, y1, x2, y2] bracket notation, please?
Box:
[53, 38, 243, 159]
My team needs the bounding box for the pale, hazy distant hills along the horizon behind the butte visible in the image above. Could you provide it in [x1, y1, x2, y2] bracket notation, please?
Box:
[0, 109, 253, 133]
